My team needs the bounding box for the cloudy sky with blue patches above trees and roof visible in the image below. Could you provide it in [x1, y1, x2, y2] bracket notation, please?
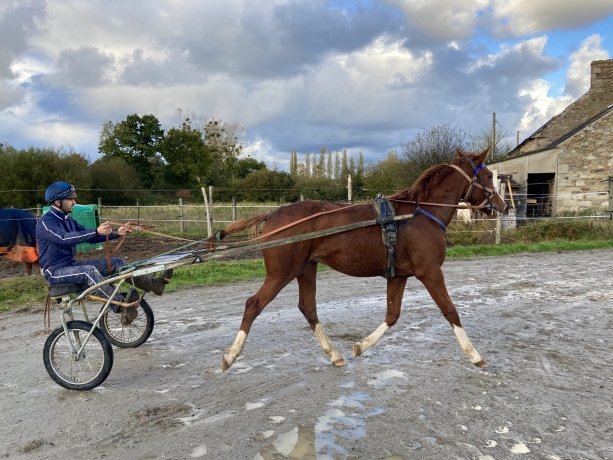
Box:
[0, 0, 613, 169]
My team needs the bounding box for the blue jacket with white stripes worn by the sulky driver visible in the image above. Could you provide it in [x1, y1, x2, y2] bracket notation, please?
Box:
[36, 206, 120, 278]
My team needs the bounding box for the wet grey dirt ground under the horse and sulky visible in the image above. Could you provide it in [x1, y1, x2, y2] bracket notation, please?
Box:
[0, 250, 613, 460]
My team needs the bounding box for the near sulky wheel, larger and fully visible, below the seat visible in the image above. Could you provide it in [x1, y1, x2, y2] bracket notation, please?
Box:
[43, 321, 113, 391]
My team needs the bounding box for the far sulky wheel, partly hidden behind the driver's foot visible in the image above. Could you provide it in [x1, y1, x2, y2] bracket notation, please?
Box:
[100, 299, 154, 348]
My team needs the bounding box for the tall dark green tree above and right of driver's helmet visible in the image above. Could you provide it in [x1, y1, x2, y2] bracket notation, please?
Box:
[98, 113, 164, 188]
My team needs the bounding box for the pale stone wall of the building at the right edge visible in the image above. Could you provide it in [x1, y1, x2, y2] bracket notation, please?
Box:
[554, 108, 613, 213]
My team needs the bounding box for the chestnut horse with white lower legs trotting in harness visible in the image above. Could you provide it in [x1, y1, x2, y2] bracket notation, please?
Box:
[218, 150, 505, 371]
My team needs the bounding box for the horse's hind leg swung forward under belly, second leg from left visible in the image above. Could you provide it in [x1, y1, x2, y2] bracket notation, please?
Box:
[297, 262, 346, 367]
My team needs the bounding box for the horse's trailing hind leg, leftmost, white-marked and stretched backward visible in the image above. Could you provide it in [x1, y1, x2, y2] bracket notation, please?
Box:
[221, 277, 291, 371]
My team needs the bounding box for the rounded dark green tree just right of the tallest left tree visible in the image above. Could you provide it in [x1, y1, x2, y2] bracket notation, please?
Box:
[161, 124, 212, 188]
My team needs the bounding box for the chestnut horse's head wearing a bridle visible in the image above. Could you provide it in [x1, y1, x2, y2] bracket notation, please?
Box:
[451, 148, 506, 218]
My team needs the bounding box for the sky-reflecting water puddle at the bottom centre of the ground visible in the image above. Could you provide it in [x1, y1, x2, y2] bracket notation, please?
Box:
[254, 392, 382, 460]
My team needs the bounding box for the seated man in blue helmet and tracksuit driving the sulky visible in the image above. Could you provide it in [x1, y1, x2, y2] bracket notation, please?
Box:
[36, 182, 173, 324]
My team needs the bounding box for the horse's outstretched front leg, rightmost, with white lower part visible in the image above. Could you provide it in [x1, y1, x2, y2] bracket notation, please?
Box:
[415, 267, 488, 368]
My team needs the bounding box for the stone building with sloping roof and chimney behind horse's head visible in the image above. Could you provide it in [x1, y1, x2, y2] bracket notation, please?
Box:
[490, 59, 613, 217]
